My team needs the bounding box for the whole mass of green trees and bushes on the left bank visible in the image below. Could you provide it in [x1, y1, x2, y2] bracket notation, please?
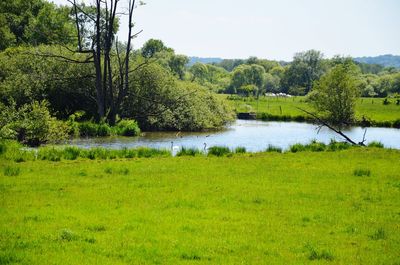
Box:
[0, 0, 234, 145]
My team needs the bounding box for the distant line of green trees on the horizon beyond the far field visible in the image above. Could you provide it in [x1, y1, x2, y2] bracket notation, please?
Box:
[188, 50, 400, 97]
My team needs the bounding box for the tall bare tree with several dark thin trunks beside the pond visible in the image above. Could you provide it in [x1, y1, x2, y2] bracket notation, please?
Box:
[67, 0, 140, 124]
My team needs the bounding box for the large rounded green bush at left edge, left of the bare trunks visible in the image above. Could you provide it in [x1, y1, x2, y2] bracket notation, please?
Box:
[0, 46, 97, 119]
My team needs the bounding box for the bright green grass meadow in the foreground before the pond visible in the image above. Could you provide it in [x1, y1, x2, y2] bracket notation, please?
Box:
[0, 148, 400, 264]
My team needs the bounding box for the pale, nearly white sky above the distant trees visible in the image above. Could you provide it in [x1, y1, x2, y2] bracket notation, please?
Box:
[52, 0, 400, 61]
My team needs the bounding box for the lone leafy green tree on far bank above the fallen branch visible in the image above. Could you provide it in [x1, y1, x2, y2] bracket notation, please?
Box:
[310, 63, 360, 130]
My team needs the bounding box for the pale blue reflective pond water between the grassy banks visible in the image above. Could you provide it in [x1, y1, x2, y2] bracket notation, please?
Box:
[69, 120, 400, 152]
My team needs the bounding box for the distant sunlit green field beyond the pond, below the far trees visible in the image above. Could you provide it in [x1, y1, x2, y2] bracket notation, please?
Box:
[221, 95, 400, 122]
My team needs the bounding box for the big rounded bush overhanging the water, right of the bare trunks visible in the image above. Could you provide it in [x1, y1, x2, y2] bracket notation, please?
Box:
[122, 64, 233, 131]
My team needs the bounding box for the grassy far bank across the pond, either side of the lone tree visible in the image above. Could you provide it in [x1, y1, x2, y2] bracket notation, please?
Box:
[225, 95, 400, 128]
